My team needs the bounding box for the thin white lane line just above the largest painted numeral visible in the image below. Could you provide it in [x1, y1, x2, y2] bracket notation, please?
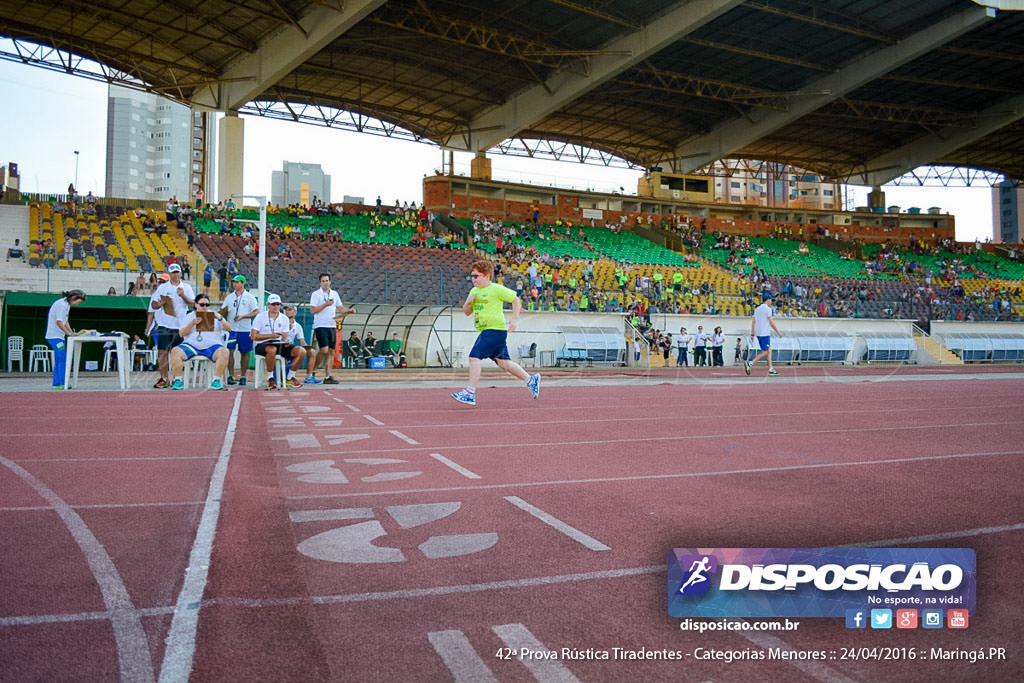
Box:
[287, 451, 1024, 501]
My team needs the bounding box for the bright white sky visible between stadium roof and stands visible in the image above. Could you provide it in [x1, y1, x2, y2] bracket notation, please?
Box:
[0, 57, 992, 241]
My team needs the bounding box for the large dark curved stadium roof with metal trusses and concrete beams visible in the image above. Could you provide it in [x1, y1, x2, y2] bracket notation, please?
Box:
[0, 0, 1024, 184]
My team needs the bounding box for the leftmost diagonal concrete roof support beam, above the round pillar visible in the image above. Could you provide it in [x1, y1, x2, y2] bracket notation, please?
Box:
[193, 0, 386, 112]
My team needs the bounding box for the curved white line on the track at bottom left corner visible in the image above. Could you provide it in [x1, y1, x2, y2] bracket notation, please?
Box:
[0, 456, 153, 681]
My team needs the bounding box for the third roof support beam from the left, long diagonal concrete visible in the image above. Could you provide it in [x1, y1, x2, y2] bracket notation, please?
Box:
[665, 6, 995, 173]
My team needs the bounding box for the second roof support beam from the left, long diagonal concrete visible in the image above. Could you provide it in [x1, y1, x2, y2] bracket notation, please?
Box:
[459, 0, 743, 152]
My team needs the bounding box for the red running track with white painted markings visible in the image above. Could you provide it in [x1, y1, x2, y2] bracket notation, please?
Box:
[0, 375, 1024, 681]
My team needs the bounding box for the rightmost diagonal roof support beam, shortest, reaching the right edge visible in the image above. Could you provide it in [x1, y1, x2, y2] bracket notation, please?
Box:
[850, 95, 1024, 186]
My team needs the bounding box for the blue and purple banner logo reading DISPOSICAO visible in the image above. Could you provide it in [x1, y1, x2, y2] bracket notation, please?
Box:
[668, 548, 977, 628]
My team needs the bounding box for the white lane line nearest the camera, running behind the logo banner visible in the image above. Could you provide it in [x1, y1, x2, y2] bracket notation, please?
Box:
[8, 522, 1024, 633]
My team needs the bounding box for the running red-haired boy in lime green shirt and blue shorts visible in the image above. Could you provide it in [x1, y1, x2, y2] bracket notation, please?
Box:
[452, 260, 541, 405]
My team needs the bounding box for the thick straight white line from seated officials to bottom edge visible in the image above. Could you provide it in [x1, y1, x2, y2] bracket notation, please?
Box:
[160, 391, 245, 683]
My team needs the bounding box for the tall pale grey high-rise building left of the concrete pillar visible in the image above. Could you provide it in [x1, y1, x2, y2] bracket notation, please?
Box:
[104, 85, 192, 202]
